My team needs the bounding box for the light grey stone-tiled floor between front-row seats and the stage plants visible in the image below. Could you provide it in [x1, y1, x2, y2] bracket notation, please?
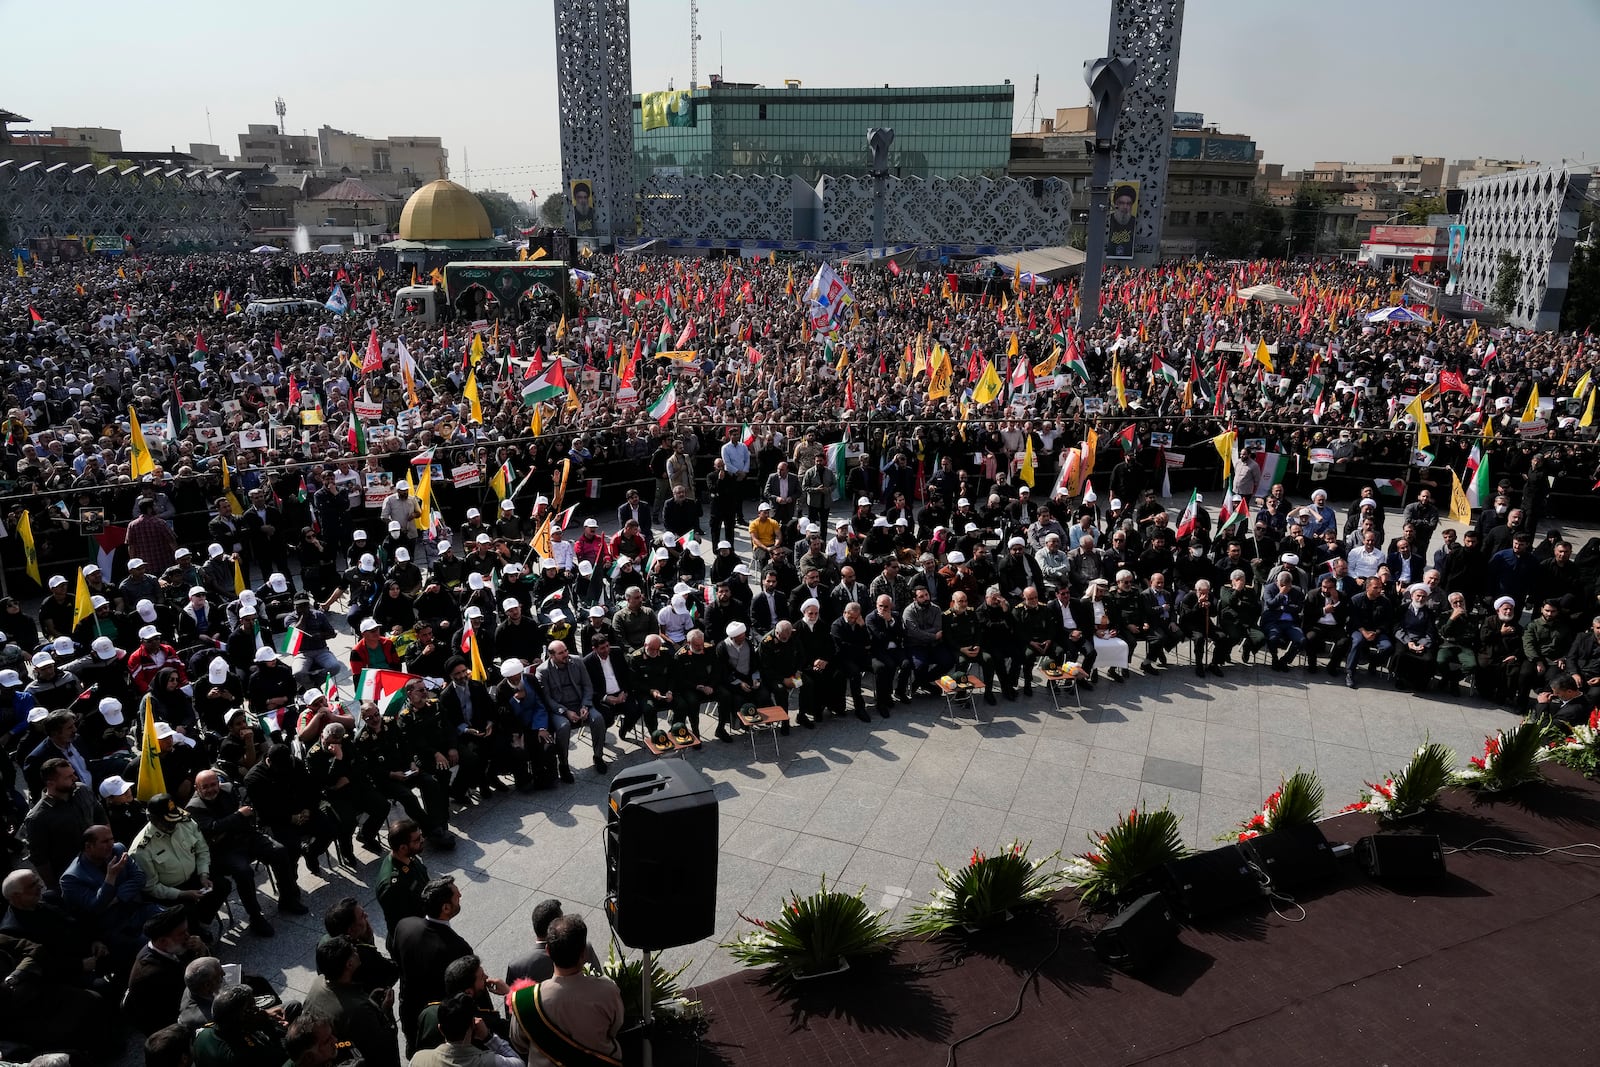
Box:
[222, 655, 1512, 995]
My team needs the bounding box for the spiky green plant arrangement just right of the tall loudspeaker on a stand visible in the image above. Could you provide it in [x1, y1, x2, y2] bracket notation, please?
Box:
[723, 877, 890, 976]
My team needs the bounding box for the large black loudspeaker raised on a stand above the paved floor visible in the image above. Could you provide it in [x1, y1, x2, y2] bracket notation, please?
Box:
[605, 760, 717, 950]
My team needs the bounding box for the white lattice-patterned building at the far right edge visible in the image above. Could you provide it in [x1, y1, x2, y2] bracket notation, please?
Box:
[1461, 162, 1595, 330]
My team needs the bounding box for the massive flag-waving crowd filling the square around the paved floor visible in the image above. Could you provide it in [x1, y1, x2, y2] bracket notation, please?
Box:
[0, 244, 1600, 1065]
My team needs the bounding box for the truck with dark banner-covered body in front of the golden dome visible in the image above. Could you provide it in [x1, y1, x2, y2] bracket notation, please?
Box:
[392, 259, 571, 325]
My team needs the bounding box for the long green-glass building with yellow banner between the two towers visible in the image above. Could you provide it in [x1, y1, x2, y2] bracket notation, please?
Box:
[632, 77, 1014, 186]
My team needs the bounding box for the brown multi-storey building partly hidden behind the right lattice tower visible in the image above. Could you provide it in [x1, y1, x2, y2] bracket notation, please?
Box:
[1006, 107, 1261, 256]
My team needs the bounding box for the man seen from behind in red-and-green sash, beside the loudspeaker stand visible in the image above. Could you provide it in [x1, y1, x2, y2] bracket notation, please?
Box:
[506, 915, 622, 1067]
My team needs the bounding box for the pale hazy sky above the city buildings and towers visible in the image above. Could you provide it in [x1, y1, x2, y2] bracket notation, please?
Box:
[0, 0, 1600, 198]
